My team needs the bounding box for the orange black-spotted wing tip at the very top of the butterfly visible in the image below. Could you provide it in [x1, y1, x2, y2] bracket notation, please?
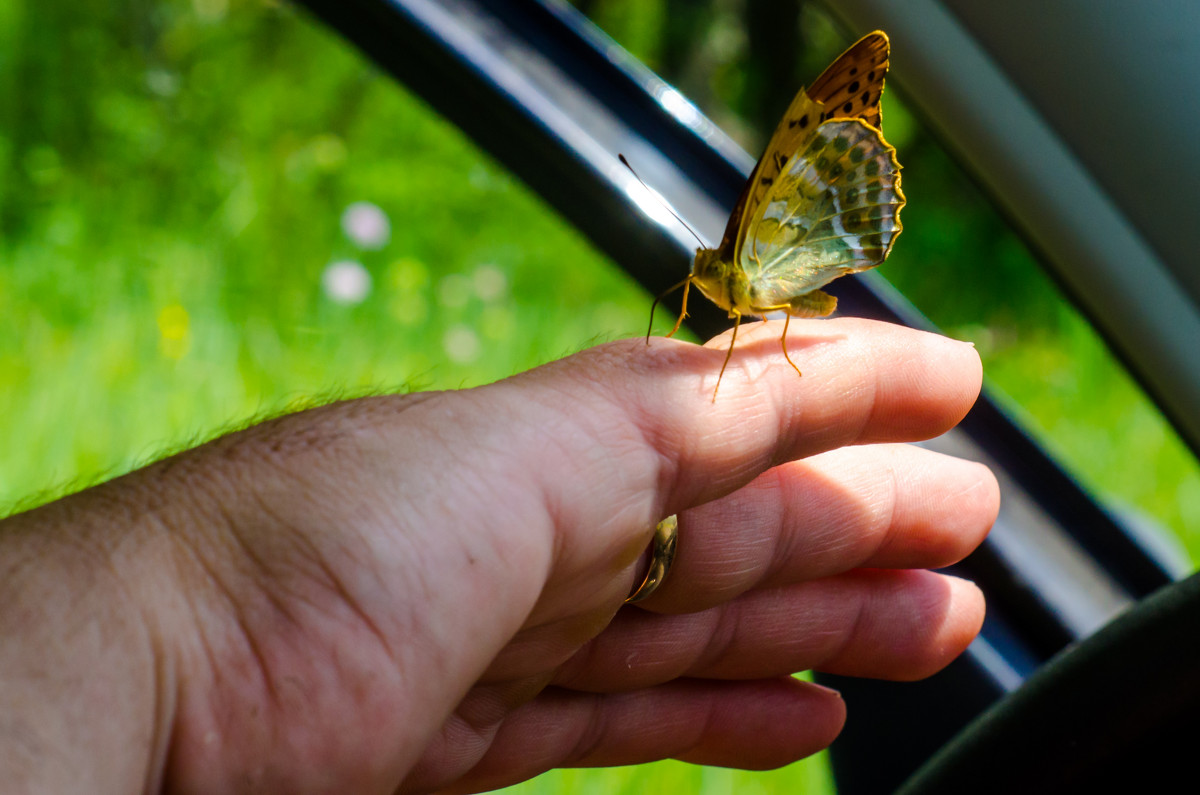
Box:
[808, 30, 890, 130]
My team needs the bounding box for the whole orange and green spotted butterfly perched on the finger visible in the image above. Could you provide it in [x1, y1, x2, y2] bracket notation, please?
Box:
[647, 30, 905, 402]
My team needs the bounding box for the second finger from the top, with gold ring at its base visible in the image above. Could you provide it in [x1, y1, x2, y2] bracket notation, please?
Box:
[642, 444, 1000, 612]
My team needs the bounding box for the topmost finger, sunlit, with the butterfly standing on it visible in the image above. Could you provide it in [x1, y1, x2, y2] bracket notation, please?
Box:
[511, 318, 982, 521]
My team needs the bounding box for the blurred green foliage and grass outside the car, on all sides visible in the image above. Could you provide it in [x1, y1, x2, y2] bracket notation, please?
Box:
[0, 0, 1200, 793]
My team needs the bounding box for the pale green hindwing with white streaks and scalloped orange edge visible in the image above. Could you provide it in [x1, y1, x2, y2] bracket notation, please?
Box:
[739, 119, 905, 309]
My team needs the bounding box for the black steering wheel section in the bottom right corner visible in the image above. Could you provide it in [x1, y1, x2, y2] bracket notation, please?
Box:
[898, 574, 1200, 795]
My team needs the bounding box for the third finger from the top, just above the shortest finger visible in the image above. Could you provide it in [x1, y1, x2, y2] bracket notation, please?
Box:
[554, 569, 983, 692]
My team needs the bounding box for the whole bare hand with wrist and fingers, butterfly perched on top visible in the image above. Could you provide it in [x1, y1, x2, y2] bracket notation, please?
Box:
[0, 318, 998, 793]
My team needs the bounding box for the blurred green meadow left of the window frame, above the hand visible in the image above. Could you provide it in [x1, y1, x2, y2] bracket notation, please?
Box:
[0, 0, 647, 503]
